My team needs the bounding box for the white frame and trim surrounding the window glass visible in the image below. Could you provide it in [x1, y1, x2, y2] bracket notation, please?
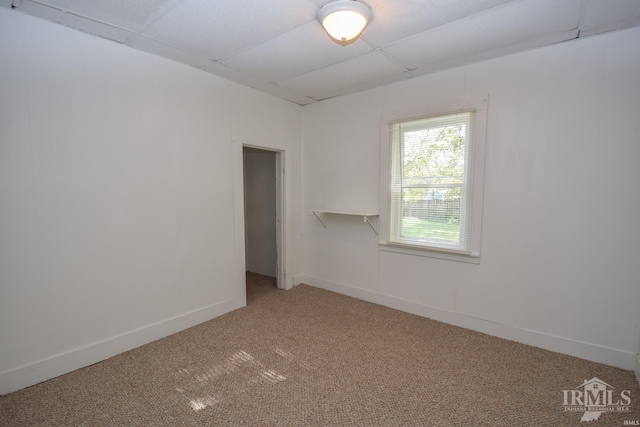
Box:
[379, 95, 489, 264]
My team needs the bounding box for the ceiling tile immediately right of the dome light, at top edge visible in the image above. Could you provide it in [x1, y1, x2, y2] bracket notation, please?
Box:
[364, 0, 516, 47]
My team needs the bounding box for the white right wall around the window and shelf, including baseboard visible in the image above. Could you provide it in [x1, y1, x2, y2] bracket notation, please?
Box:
[300, 28, 640, 369]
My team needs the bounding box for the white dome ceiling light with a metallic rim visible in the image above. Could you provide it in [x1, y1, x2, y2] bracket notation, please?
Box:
[318, 0, 373, 45]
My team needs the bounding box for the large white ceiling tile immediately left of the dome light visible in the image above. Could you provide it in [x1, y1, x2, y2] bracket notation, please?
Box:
[145, 0, 317, 60]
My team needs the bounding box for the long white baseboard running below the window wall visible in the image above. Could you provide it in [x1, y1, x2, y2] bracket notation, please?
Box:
[300, 275, 638, 375]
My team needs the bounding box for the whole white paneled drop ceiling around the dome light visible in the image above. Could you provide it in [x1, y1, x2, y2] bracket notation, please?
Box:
[5, 0, 640, 105]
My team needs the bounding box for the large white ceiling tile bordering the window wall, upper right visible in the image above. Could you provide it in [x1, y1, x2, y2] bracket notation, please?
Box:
[384, 0, 580, 69]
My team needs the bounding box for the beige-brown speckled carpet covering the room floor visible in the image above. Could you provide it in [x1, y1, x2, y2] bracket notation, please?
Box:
[0, 273, 640, 427]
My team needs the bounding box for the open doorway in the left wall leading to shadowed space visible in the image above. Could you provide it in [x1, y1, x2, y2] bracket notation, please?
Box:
[242, 146, 285, 289]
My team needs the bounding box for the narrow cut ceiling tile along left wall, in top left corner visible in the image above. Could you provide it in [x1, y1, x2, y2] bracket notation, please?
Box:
[18, 0, 131, 43]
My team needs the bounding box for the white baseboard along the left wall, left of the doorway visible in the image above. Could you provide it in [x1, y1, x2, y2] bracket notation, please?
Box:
[0, 298, 244, 395]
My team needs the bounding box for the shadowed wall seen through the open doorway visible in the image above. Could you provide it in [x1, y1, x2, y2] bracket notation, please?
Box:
[244, 149, 277, 277]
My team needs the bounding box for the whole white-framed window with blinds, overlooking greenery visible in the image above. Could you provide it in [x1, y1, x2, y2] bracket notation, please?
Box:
[380, 97, 487, 262]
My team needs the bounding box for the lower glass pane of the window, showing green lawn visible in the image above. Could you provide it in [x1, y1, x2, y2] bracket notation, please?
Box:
[400, 187, 461, 245]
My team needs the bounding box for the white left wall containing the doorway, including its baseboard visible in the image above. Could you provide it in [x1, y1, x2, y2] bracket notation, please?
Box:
[0, 8, 302, 394]
